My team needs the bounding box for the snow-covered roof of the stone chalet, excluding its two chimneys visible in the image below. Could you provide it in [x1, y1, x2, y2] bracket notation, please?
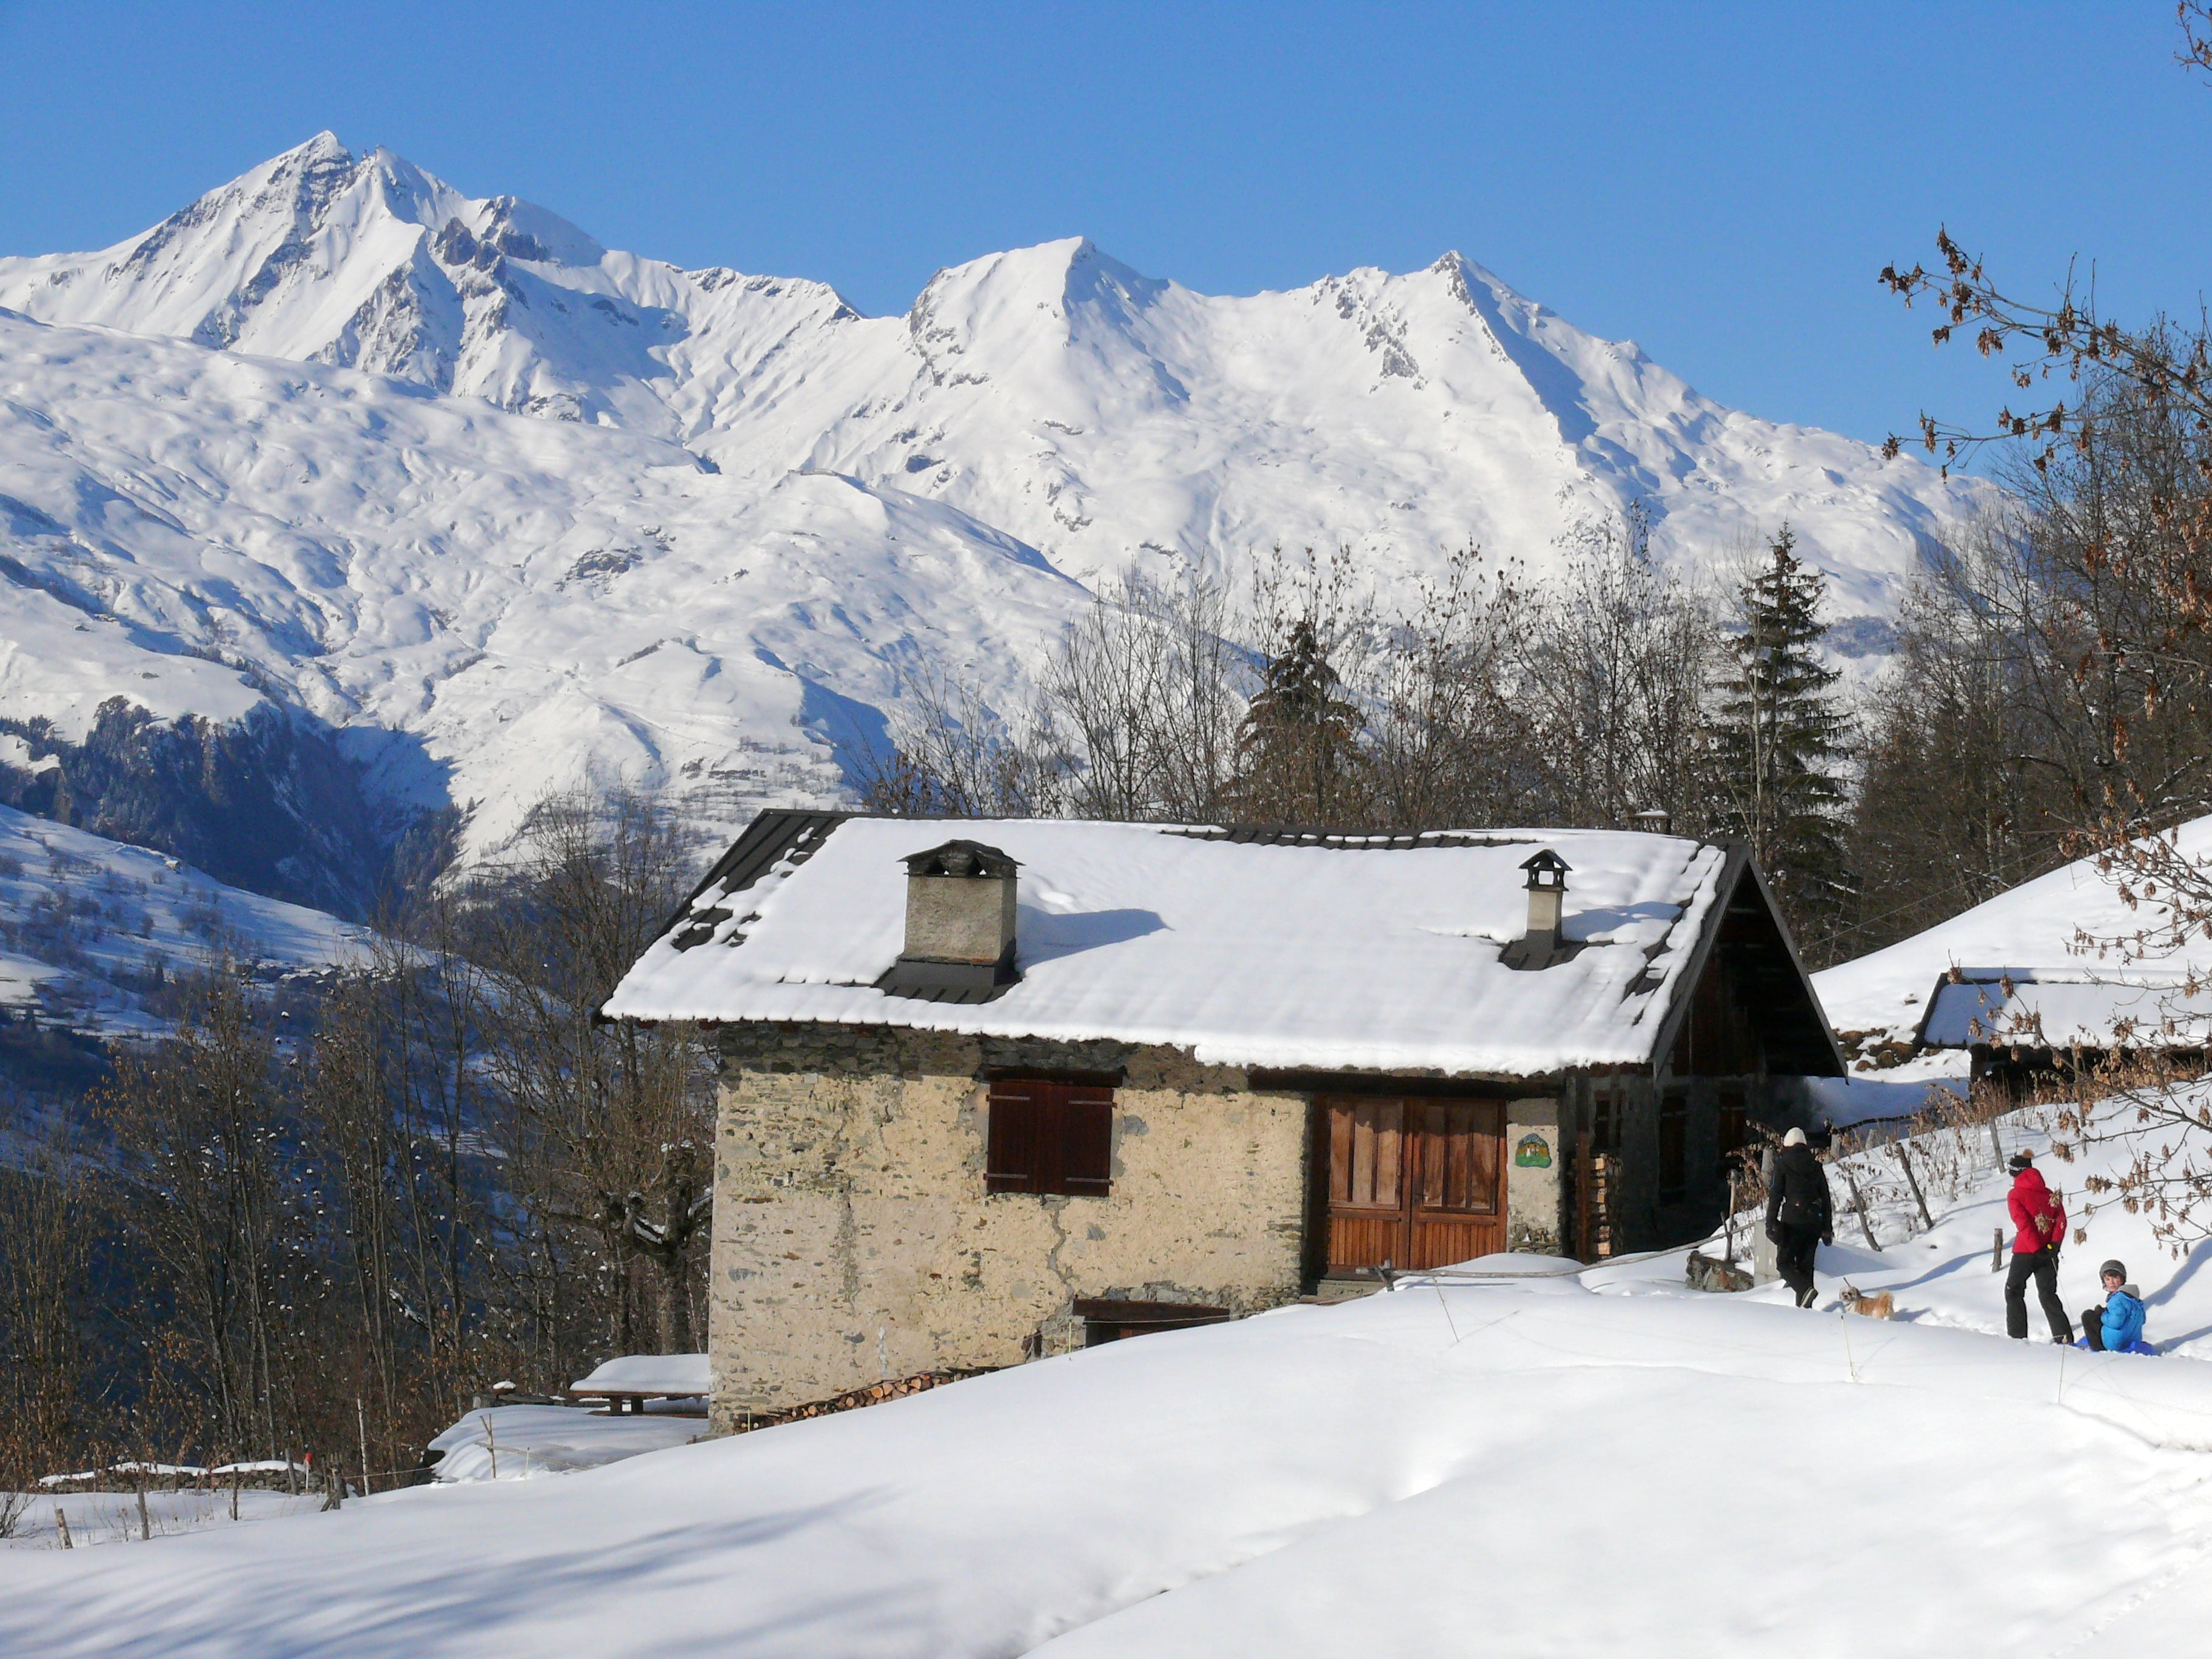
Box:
[606, 814, 1834, 1078]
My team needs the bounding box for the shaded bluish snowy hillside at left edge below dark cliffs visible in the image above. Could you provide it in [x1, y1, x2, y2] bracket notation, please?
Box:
[0, 808, 369, 1035]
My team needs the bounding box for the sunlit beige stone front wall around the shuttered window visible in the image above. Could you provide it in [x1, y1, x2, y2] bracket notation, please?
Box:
[710, 1027, 1310, 1427]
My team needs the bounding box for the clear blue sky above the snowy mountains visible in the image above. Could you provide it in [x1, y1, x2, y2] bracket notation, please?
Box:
[0, 0, 2212, 451]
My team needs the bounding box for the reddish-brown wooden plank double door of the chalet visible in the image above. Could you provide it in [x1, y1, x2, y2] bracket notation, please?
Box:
[1318, 1095, 1506, 1272]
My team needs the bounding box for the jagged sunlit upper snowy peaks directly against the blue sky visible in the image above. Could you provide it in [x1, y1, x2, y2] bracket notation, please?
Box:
[0, 135, 1971, 615]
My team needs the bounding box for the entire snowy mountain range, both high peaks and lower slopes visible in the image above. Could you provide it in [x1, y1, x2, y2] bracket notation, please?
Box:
[0, 133, 1971, 876]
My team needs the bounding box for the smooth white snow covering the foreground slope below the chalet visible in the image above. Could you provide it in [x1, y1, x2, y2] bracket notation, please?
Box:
[13, 1097, 2212, 1659]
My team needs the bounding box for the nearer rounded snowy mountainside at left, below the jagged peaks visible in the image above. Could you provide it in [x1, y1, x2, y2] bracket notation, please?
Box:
[0, 314, 1086, 845]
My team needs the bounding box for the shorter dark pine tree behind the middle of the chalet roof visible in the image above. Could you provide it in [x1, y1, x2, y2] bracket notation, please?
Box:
[1235, 617, 1367, 825]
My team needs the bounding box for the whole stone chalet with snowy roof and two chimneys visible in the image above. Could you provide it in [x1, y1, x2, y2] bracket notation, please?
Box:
[606, 812, 1843, 1424]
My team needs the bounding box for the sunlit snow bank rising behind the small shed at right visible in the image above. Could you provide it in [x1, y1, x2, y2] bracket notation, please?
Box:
[1812, 819, 2212, 1042]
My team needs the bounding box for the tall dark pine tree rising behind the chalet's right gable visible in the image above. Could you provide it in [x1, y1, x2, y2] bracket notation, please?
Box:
[1712, 525, 1851, 956]
